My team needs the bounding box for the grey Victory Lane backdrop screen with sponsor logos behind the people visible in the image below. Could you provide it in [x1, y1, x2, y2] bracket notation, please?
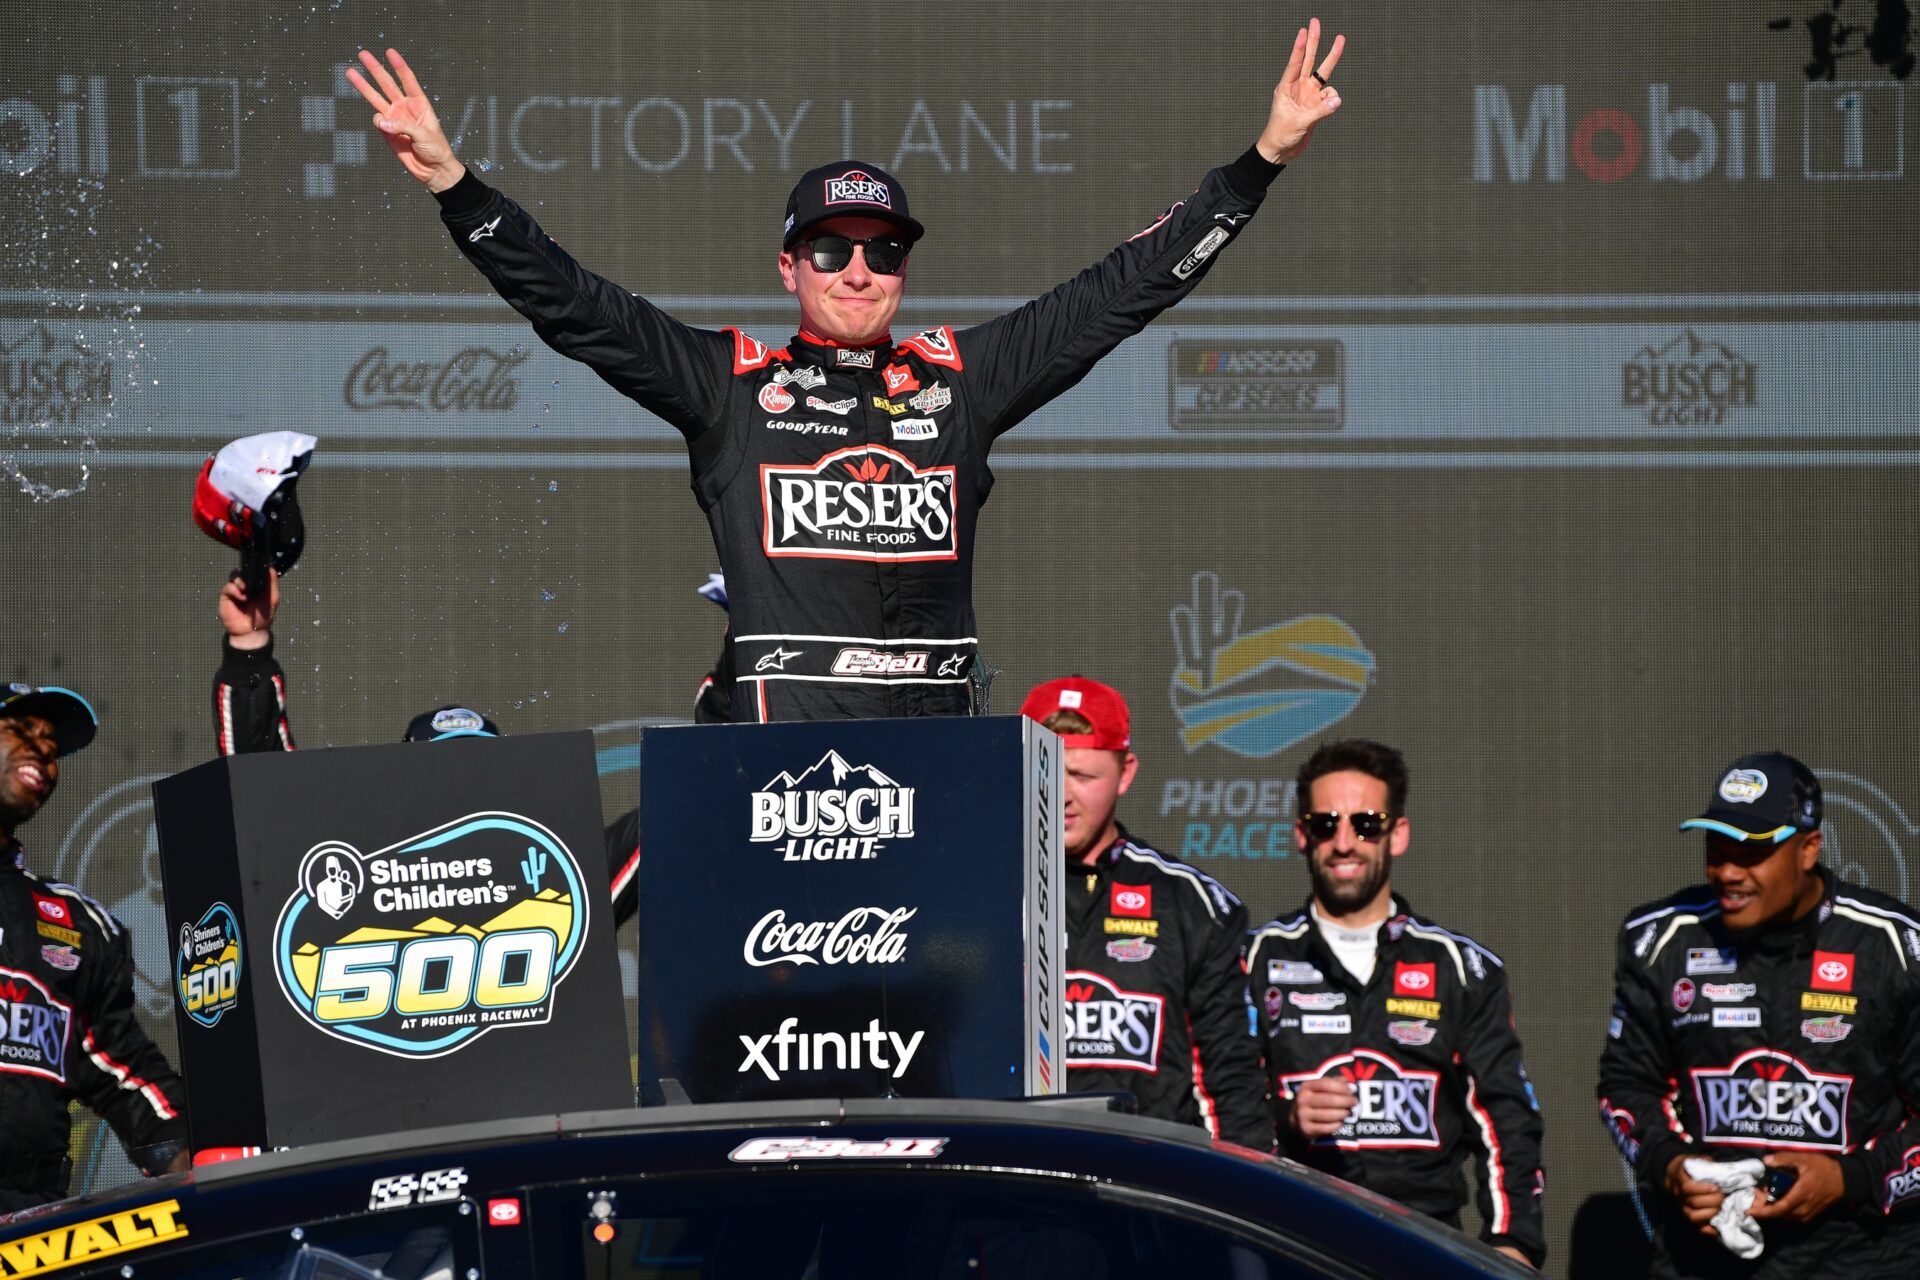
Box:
[0, 0, 1920, 1267]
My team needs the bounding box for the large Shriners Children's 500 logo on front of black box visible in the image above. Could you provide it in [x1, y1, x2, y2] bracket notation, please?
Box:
[273, 814, 591, 1057]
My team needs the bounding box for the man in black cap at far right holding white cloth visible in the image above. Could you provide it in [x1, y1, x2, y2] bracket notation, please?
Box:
[1599, 752, 1920, 1280]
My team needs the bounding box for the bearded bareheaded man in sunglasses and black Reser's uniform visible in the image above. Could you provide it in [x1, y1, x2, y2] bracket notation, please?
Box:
[1246, 739, 1546, 1267]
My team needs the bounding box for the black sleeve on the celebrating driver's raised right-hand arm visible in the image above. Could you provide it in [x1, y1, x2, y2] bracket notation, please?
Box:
[956, 148, 1283, 441]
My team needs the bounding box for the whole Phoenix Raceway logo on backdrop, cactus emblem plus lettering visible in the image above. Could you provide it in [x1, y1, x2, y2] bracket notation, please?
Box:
[1160, 572, 1375, 860]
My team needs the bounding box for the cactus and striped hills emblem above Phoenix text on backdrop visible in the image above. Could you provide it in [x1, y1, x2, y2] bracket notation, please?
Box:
[1167, 574, 1373, 760]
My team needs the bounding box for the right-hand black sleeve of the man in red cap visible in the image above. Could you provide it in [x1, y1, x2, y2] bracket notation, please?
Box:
[1187, 885, 1273, 1151]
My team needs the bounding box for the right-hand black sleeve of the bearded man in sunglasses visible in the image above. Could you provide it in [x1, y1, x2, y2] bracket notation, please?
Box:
[1459, 952, 1548, 1267]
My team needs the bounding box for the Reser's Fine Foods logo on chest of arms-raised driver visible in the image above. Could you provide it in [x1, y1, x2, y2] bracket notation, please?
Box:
[760, 445, 960, 560]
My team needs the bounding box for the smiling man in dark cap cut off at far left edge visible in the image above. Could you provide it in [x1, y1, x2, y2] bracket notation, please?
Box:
[0, 685, 188, 1213]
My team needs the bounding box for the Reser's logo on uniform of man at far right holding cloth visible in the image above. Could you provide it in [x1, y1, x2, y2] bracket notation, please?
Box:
[1688, 1050, 1853, 1151]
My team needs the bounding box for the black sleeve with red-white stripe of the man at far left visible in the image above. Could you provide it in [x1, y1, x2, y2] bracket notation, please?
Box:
[71, 904, 186, 1173]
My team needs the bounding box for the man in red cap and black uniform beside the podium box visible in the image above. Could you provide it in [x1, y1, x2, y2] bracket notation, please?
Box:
[1020, 676, 1273, 1151]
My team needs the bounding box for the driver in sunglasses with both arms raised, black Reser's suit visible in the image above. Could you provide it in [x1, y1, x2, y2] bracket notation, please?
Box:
[348, 19, 1344, 722]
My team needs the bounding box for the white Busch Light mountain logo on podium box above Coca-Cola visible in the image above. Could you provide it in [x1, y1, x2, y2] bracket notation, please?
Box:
[749, 750, 914, 862]
